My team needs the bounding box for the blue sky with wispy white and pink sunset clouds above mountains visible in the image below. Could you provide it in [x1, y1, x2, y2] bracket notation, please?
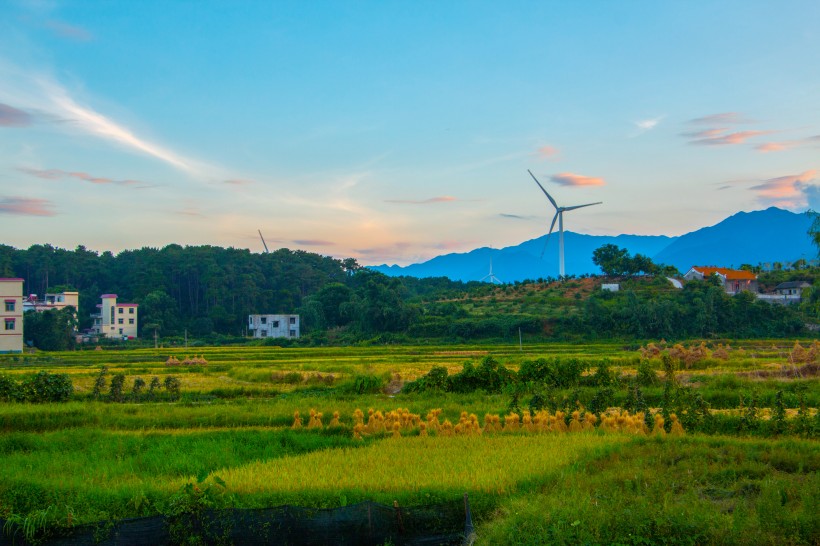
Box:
[0, 0, 820, 265]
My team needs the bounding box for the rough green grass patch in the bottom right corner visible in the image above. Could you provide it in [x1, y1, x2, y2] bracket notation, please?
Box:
[478, 436, 820, 545]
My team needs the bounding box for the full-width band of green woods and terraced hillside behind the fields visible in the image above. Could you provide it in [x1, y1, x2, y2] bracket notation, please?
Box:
[0, 241, 820, 348]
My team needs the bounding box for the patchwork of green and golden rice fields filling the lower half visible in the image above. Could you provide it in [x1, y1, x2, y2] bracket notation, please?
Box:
[0, 340, 820, 544]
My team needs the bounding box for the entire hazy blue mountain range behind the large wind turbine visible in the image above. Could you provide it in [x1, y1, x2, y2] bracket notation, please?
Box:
[369, 207, 817, 282]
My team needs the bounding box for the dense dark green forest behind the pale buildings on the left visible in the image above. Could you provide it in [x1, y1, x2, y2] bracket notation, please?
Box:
[0, 245, 479, 340]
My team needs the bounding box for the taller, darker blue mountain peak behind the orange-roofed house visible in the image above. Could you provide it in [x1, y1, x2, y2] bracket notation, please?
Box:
[653, 207, 817, 273]
